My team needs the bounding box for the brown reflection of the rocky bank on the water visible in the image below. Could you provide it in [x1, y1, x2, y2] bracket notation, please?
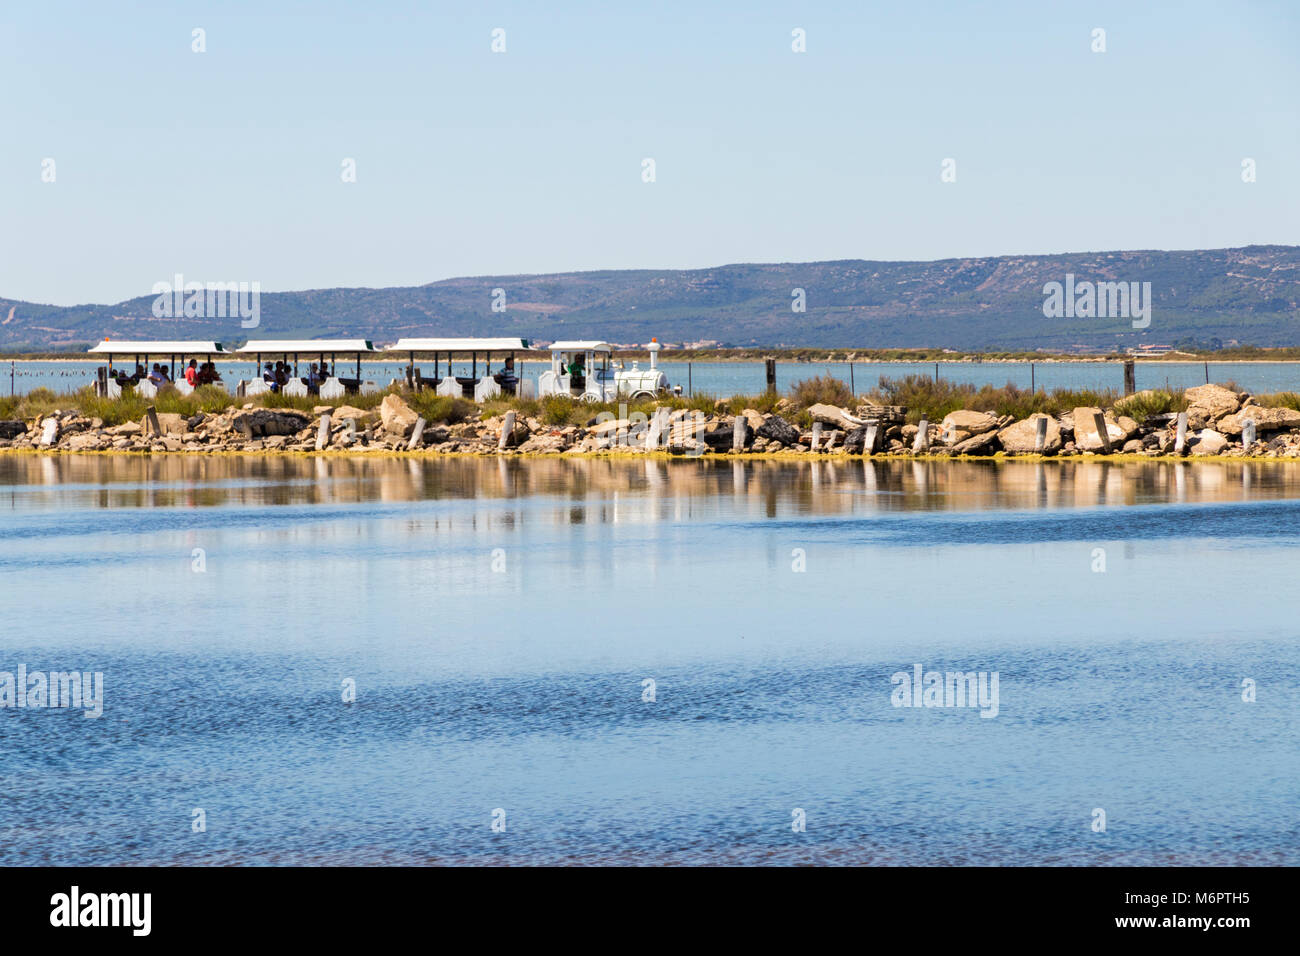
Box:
[0, 455, 1300, 520]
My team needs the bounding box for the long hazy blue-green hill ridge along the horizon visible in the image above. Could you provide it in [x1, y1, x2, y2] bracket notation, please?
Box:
[0, 246, 1300, 351]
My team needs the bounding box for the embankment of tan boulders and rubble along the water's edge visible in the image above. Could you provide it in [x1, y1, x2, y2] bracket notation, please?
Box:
[0, 385, 1300, 458]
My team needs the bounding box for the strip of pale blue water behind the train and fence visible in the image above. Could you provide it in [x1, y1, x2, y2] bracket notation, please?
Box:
[0, 360, 1300, 397]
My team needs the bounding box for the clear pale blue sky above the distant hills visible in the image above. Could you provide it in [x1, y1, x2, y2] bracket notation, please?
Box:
[0, 0, 1300, 304]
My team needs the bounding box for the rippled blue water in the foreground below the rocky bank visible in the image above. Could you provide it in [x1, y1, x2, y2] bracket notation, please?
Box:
[0, 455, 1300, 865]
